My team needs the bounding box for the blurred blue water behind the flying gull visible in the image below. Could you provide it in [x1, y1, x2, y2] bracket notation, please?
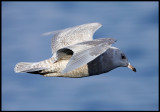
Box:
[2, 2, 159, 111]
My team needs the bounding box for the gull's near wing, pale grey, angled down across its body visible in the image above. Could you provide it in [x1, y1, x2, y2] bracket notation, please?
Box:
[59, 38, 116, 73]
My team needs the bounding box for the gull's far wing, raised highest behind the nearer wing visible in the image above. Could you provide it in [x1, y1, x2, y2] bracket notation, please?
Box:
[43, 23, 102, 54]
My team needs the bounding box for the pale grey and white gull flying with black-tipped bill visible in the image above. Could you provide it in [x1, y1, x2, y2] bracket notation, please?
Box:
[14, 23, 136, 78]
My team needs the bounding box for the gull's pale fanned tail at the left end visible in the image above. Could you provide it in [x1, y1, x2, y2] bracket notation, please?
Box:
[14, 62, 46, 73]
